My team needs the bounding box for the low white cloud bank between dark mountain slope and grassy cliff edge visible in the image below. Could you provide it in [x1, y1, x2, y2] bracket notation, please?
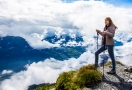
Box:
[1, 51, 94, 90]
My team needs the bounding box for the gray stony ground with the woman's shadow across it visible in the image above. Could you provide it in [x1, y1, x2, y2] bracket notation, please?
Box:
[96, 64, 132, 90]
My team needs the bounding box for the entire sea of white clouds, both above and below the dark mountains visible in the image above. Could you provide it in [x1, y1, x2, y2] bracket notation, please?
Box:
[0, 0, 132, 90]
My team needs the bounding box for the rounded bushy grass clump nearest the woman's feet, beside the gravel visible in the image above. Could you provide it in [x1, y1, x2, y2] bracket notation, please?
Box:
[75, 64, 102, 88]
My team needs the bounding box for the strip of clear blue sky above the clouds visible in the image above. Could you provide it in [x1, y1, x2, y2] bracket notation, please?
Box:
[62, 0, 132, 6]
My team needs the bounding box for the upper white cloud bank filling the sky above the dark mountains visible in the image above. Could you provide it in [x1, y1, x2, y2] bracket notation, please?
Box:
[0, 0, 132, 49]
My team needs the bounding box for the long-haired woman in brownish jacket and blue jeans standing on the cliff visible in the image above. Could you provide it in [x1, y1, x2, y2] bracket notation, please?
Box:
[95, 17, 117, 74]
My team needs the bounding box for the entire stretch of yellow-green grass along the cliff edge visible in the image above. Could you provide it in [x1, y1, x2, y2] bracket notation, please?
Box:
[35, 64, 102, 90]
